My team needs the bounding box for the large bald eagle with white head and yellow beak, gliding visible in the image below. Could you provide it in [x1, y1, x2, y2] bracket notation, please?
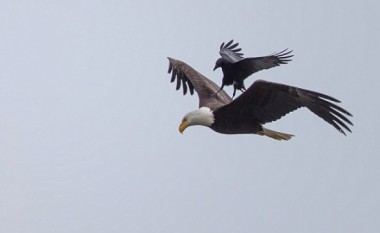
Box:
[168, 57, 353, 140]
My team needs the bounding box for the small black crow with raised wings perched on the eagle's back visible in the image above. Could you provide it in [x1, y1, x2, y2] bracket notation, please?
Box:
[214, 40, 293, 97]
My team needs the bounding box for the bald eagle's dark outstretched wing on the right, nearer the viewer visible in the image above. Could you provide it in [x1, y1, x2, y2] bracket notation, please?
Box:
[215, 80, 353, 135]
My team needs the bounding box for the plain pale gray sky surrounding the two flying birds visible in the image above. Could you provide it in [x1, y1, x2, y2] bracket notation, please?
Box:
[0, 0, 380, 233]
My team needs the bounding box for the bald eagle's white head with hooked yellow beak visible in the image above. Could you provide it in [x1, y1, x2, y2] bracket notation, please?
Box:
[179, 107, 215, 133]
